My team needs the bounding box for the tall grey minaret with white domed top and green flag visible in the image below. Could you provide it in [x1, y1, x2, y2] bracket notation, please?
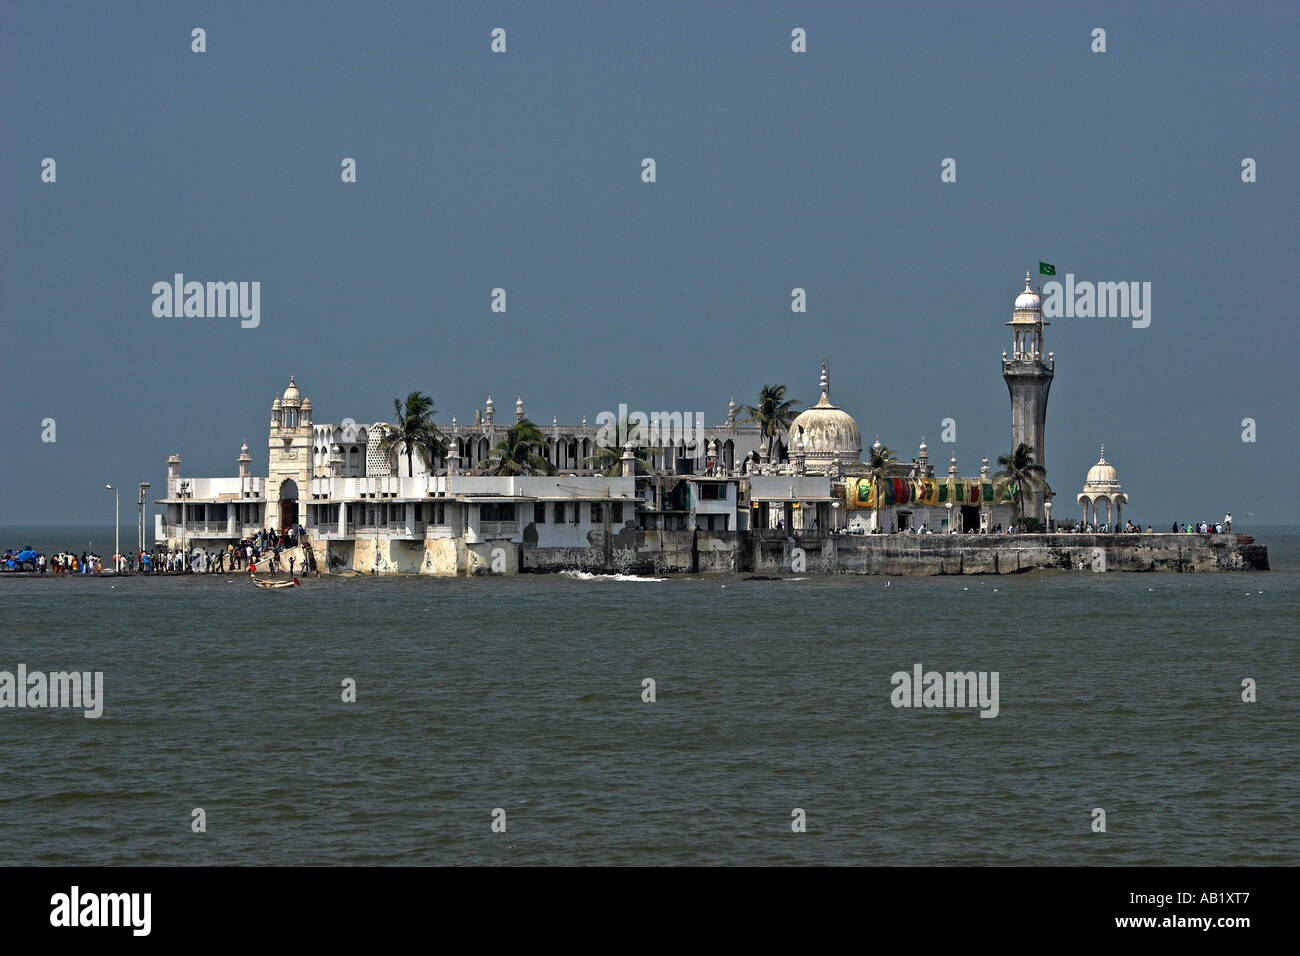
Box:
[1002, 272, 1056, 519]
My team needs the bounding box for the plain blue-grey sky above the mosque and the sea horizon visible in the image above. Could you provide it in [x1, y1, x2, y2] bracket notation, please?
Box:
[0, 0, 1300, 527]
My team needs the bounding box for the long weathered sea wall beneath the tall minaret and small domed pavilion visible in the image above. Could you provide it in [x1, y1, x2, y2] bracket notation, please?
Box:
[745, 532, 1268, 575]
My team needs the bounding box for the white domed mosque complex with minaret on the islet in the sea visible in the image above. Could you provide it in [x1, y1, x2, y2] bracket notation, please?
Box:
[155, 274, 1237, 575]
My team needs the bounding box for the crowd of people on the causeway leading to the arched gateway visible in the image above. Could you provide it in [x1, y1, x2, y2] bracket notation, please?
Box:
[13, 525, 320, 578]
